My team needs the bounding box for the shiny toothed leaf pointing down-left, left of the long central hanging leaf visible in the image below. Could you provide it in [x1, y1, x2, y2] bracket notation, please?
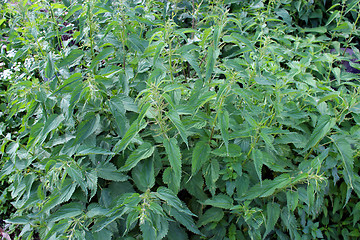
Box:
[120, 142, 155, 171]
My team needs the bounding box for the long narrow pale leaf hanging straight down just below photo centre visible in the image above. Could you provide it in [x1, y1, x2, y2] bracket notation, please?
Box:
[164, 138, 181, 191]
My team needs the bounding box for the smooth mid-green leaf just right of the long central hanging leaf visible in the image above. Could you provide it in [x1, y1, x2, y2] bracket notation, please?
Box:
[191, 141, 211, 175]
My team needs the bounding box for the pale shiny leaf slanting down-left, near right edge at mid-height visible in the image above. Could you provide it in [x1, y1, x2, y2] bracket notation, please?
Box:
[304, 115, 336, 151]
